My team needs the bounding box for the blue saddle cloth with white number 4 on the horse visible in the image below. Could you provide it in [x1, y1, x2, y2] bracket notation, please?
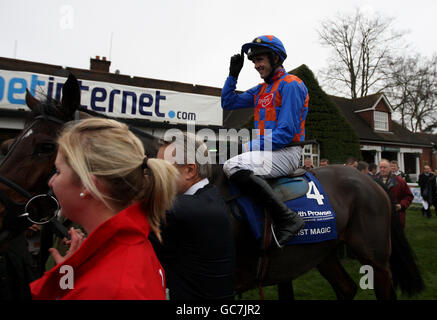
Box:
[229, 171, 337, 244]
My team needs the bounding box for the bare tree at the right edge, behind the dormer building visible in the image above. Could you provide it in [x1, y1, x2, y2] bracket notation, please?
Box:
[385, 54, 437, 133]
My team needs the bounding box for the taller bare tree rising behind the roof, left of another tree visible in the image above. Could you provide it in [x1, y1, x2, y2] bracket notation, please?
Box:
[318, 9, 403, 99]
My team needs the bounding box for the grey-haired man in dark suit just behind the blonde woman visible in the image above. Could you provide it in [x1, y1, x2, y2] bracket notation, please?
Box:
[152, 133, 235, 300]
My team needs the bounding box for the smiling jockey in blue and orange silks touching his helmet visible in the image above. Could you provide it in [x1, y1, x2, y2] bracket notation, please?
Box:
[221, 36, 309, 247]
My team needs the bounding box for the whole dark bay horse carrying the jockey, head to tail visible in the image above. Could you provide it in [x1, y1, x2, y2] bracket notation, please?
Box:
[0, 76, 423, 299]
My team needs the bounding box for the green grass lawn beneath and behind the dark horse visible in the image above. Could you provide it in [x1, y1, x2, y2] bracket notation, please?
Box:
[242, 205, 437, 300]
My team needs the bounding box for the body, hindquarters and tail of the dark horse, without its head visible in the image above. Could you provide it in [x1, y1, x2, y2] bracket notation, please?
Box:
[215, 165, 424, 299]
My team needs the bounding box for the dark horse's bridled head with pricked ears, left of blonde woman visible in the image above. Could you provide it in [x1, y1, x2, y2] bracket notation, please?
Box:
[0, 75, 80, 235]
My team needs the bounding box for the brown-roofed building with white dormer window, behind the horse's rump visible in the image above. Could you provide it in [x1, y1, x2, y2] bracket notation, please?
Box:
[330, 93, 437, 181]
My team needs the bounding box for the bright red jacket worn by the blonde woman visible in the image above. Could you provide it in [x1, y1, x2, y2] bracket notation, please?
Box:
[30, 204, 165, 300]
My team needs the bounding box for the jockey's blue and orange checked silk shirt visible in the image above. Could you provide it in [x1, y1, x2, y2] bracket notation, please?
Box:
[221, 69, 309, 151]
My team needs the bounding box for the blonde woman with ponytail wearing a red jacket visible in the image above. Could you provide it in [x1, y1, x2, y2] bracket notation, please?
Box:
[31, 118, 178, 299]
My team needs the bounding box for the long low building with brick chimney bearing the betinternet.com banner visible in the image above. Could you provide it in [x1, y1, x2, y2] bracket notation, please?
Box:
[0, 56, 223, 161]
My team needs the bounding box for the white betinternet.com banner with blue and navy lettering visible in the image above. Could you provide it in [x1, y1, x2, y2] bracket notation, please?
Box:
[0, 70, 223, 126]
